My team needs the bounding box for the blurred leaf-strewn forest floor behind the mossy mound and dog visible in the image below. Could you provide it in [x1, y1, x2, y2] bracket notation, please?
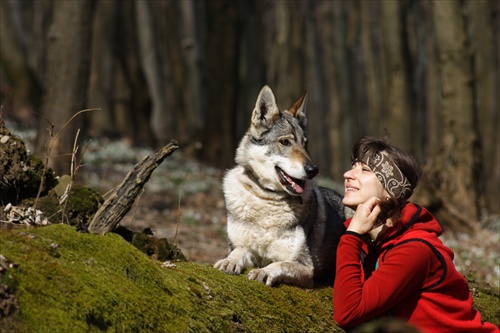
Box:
[7, 122, 500, 288]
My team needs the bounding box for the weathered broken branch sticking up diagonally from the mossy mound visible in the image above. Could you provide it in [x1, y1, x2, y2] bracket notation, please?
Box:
[88, 141, 179, 235]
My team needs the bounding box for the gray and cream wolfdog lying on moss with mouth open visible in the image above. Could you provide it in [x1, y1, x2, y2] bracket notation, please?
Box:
[214, 86, 345, 288]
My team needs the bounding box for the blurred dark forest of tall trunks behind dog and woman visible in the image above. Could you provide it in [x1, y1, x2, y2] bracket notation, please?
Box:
[0, 0, 500, 230]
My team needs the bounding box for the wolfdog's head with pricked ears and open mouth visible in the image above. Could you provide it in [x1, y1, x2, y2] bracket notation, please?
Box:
[236, 86, 318, 196]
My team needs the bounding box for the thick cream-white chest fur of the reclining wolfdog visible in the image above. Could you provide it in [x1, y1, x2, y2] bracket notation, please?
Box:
[223, 166, 310, 265]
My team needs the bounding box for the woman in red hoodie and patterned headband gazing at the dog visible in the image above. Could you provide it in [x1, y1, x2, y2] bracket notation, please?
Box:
[333, 137, 499, 332]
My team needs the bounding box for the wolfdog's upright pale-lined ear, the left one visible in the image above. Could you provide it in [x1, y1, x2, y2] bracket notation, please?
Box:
[252, 85, 280, 130]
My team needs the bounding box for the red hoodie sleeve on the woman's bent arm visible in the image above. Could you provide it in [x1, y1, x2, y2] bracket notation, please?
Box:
[333, 234, 433, 328]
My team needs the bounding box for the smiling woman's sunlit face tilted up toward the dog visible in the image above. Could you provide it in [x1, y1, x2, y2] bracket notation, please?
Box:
[342, 162, 389, 209]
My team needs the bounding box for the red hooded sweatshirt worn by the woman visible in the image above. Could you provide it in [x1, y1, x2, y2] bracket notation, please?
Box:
[333, 203, 499, 333]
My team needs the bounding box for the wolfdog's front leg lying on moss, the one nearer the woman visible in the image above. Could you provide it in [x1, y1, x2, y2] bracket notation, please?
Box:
[247, 261, 314, 288]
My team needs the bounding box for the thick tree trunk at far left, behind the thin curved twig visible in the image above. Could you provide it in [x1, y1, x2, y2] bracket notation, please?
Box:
[36, 0, 92, 175]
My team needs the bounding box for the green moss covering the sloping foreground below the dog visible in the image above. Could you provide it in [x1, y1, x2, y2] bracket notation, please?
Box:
[0, 225, 500, 332]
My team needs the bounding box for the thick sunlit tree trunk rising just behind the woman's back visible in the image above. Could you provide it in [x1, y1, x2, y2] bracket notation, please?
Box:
[426, 1, 479, 226]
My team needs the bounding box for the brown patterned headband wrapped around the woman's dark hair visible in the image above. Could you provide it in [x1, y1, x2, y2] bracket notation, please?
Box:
[360, 152, 413, 202]
